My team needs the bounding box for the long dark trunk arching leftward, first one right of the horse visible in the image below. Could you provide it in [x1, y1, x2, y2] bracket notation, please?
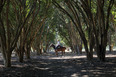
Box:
[54, 0, 91, 60]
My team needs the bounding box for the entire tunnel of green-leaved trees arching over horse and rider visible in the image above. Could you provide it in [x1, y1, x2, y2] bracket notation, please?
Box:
[0, 0, 116, 67]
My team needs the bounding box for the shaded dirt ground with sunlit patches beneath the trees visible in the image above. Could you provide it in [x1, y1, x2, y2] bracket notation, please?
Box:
[0, 53, 116, 77]
